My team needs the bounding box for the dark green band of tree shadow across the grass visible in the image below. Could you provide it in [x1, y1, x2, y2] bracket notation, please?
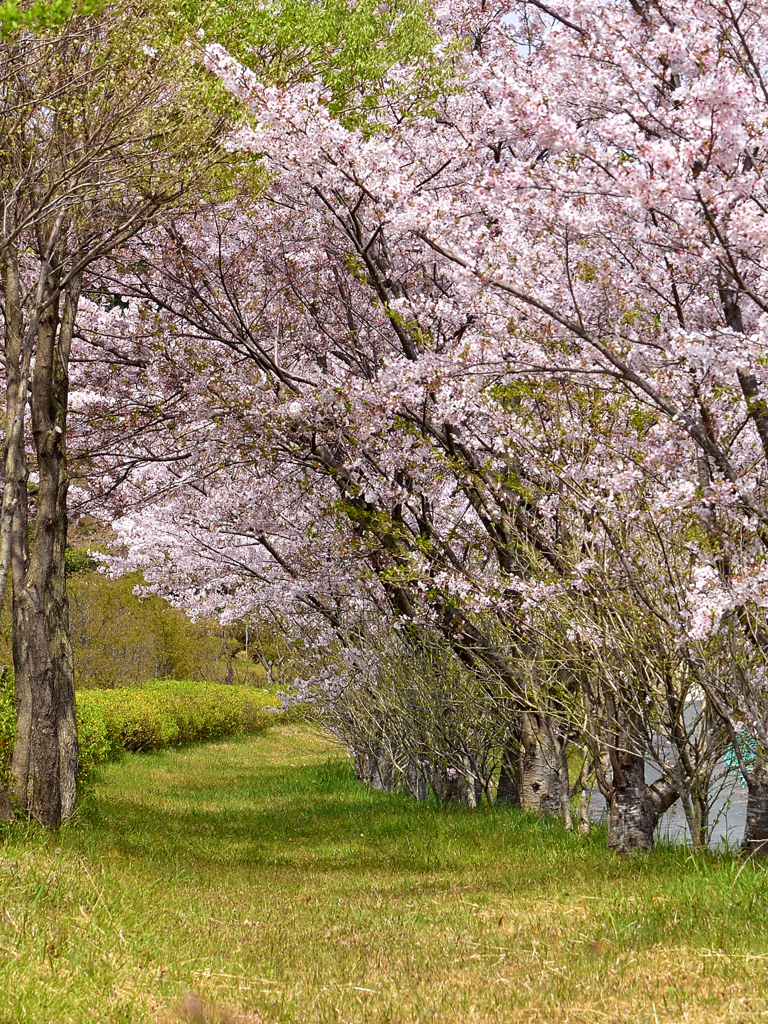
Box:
[61, 754, 589, 884]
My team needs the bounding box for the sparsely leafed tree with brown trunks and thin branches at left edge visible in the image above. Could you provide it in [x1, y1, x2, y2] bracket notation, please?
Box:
[0, 5, 228, 825]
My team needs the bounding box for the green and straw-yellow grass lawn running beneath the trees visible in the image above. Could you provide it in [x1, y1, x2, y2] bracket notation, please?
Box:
[0, 726, 768, 1024]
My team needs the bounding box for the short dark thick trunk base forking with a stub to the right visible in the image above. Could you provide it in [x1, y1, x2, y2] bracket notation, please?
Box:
[608, 751, 679, 853]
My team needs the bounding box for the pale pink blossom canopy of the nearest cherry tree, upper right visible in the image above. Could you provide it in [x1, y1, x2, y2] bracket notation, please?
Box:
[196, 3, 766, 845]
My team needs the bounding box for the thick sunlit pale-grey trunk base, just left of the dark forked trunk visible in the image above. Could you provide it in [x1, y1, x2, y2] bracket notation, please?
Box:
[519, 712, 569, 823]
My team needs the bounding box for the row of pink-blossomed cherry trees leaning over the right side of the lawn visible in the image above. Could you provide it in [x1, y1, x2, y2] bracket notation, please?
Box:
[3, 0, 768, 853]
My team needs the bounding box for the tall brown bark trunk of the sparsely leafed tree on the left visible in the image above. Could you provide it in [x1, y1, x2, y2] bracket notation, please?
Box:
[12, 270, 80, 826]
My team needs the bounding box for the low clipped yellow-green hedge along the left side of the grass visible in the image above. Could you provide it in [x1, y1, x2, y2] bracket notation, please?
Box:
[0, 675, 278, 780]
